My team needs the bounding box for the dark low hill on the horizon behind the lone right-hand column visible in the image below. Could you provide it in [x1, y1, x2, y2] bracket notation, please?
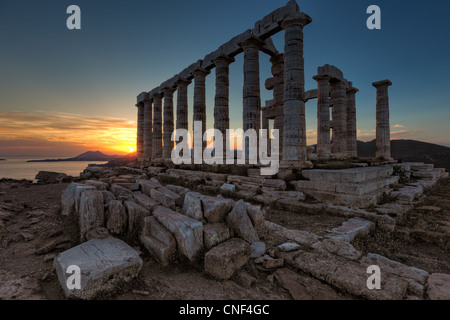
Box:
[358, 140, 450, 170]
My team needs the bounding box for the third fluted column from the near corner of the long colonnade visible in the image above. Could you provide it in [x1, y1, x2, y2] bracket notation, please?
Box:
[213, 55, 234, 158]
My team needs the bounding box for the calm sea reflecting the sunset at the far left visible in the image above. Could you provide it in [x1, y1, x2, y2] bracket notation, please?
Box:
[0, 157, 106, 180]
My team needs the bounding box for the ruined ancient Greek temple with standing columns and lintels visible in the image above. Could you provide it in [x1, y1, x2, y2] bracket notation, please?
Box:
[136, 0, 391, 165]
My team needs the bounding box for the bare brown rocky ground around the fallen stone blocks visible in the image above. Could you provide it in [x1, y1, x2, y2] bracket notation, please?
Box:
[0, 179, 450, 300]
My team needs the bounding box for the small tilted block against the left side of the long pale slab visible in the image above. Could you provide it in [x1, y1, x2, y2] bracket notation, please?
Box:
[140, 217, 177, 266]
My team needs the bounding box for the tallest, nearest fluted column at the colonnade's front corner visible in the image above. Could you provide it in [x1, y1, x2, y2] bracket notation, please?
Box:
[281, 12, 312, 163]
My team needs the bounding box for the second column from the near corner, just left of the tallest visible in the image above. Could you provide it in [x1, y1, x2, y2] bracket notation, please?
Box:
[240, 37, 264, 159]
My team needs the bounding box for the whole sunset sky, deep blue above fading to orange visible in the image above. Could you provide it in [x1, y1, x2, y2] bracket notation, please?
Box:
[0, 0, 450, 157]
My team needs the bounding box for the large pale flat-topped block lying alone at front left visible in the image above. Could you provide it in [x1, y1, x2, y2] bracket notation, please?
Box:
[53, 238, 142, 300]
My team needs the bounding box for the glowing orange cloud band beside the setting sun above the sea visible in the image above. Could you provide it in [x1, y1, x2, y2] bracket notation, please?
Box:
[0, 112, 136, 157]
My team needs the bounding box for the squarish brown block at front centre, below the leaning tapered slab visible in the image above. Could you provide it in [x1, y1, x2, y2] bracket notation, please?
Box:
[205, 238, 250, 279]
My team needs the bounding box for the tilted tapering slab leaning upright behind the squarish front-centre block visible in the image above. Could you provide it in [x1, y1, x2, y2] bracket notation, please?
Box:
[226, 200, 259, 243]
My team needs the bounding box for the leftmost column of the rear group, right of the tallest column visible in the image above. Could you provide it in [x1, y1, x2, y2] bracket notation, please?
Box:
[313, 75, 331, 159]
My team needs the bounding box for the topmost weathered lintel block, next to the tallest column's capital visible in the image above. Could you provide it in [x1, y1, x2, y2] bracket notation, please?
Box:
[253, 0, 300, 40]
